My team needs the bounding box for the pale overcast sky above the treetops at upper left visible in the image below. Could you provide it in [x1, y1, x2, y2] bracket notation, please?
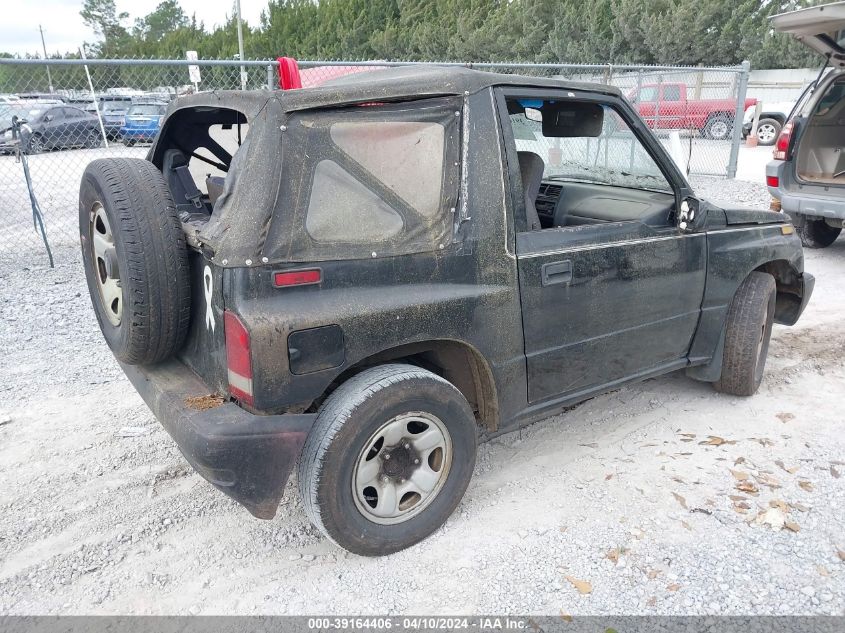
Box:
[0, 0, 267, 55]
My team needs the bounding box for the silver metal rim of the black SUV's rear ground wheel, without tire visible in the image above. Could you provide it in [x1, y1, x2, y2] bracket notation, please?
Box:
[352, 411, 452, 525]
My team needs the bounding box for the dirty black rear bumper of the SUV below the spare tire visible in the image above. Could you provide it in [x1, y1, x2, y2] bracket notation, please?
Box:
[121, 359, 316, 519]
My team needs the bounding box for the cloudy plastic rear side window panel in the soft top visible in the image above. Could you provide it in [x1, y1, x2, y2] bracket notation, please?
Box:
[266, 99, 461, 261]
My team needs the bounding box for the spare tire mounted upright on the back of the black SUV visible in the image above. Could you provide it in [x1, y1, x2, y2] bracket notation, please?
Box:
[79, 158, 191, 365]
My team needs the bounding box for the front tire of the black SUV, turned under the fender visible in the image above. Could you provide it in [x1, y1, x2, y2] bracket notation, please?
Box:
[713, 271, 777, 396]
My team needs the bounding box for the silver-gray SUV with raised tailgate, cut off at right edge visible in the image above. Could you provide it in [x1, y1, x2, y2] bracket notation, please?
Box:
[766, 2, 845, 248]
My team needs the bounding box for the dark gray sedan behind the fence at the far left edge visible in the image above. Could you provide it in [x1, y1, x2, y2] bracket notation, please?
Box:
[0, 101, 102, 154]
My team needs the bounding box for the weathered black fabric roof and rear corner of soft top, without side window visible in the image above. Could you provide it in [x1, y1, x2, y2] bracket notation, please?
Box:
[148, 66, 621, 266]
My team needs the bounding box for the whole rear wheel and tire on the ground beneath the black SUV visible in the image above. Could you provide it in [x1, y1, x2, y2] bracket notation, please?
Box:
[299, 364, 477, 556]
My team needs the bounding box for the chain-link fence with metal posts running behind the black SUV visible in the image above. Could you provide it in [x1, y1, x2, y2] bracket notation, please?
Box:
[0, 59, 749, 270]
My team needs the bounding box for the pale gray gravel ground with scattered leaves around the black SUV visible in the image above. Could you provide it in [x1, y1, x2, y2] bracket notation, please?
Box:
[0, 179, 845, 615]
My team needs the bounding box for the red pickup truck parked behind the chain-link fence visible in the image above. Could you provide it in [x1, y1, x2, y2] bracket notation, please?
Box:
[628, 82, 757, 141]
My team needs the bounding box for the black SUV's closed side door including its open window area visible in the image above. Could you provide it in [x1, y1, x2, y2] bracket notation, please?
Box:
[499, 87, 706, 404]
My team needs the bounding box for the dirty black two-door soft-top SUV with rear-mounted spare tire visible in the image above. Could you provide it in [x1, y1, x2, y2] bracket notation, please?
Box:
[79, 67, 813, 555]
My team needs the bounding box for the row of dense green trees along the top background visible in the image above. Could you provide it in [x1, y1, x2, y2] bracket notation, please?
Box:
[0, 0, 836, 68]
